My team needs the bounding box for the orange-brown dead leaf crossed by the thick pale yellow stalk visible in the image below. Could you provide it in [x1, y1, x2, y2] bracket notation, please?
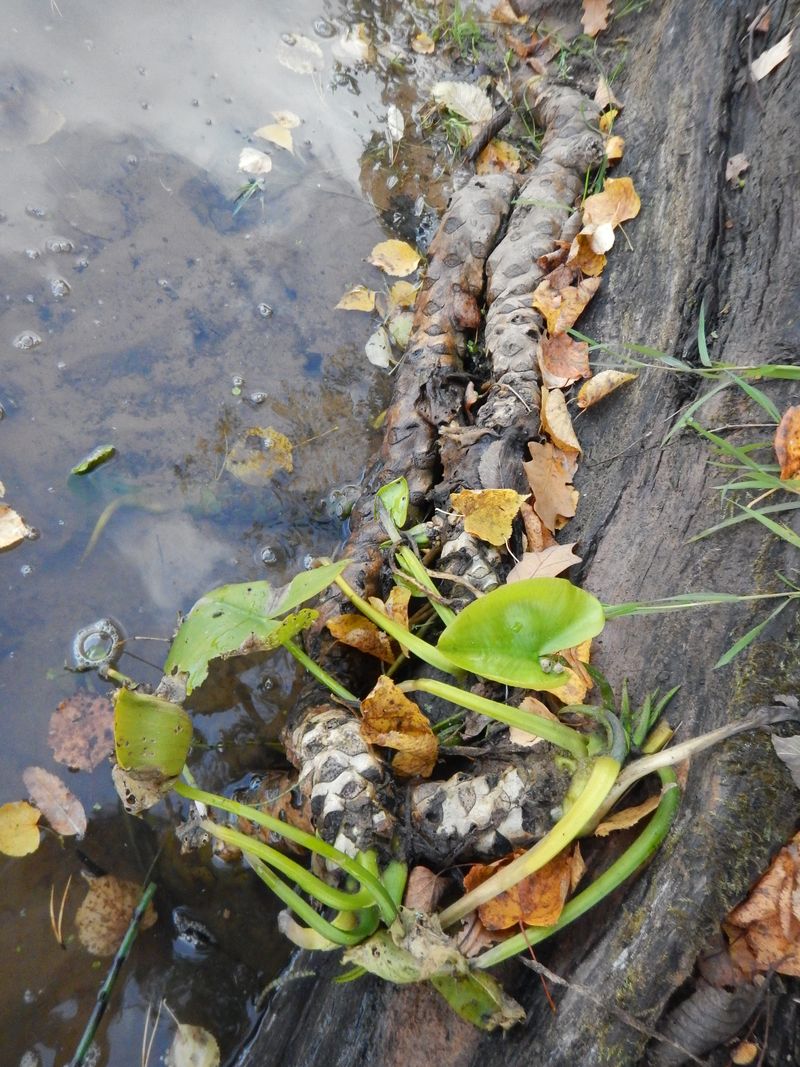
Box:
[464, 848, 573, 930]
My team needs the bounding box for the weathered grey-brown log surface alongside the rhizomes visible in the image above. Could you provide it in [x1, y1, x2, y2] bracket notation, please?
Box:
[237, 0, 800, 1067]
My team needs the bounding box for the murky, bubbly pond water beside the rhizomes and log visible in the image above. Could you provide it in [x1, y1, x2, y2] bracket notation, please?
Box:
[0, 0, 439, 1067]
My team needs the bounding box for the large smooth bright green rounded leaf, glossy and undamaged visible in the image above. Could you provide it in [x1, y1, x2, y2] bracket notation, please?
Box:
[438, 578, 605, 690]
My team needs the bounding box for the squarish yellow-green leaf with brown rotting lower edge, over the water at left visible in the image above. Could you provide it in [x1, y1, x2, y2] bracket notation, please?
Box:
[114, 688, 192, 778]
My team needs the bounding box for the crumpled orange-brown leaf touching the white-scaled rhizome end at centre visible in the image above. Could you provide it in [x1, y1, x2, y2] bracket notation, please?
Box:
[362, 674, 438, 778]
